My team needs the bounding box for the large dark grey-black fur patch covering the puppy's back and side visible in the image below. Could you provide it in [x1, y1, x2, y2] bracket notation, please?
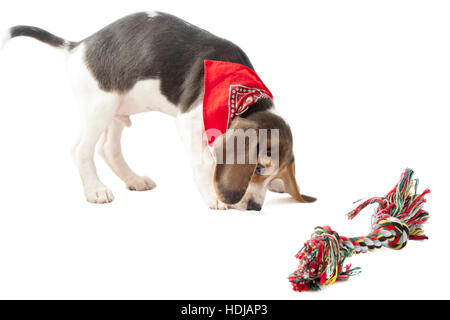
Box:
[83, 13, 253, 112]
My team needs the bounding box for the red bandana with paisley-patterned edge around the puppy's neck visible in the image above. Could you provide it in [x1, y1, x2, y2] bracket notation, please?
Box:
[203, 60, 273, 145]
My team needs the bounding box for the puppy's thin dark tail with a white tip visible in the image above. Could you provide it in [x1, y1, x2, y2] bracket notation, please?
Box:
[0, 26, 78, 51]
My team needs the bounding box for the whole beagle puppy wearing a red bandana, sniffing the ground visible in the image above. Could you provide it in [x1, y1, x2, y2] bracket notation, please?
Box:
[4, 12, 315, 211]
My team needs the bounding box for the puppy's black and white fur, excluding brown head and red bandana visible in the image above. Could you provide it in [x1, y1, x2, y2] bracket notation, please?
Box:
[4, 12, 314, 210]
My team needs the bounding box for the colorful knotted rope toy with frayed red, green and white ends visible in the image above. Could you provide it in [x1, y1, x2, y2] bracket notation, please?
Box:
[289, 169, 430, 292]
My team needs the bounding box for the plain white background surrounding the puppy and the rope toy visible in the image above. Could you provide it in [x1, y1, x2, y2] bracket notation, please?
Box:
[0, 0, 450, 299]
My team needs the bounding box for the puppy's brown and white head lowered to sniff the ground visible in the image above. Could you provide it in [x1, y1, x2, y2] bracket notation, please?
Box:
[214, 101, 315, 211]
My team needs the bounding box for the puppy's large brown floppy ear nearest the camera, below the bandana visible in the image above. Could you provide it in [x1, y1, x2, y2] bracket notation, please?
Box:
[214, 117, 258, 204]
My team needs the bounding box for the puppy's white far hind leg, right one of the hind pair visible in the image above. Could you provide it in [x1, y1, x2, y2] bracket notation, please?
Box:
[98, 120, 156, 191]
